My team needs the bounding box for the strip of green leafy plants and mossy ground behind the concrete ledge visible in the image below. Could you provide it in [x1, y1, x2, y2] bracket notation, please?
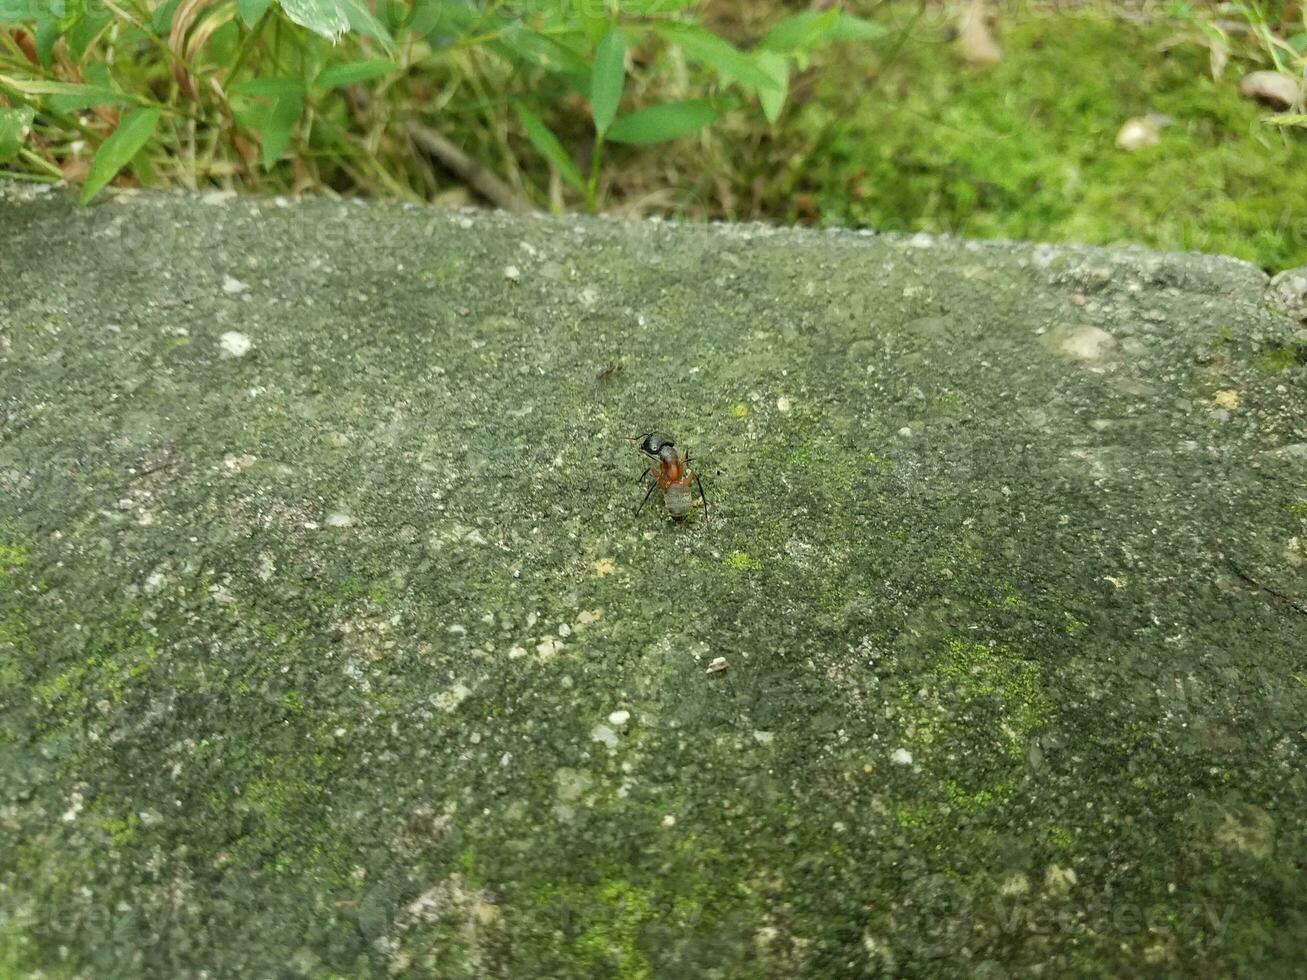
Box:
[0, 0, 1307, 269]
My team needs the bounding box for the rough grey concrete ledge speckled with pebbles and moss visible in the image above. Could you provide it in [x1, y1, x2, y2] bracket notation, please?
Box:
[0, 188, 1307, 977]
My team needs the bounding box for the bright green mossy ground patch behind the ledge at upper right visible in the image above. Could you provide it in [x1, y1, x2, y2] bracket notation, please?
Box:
[773, 12, 1307, 269]
